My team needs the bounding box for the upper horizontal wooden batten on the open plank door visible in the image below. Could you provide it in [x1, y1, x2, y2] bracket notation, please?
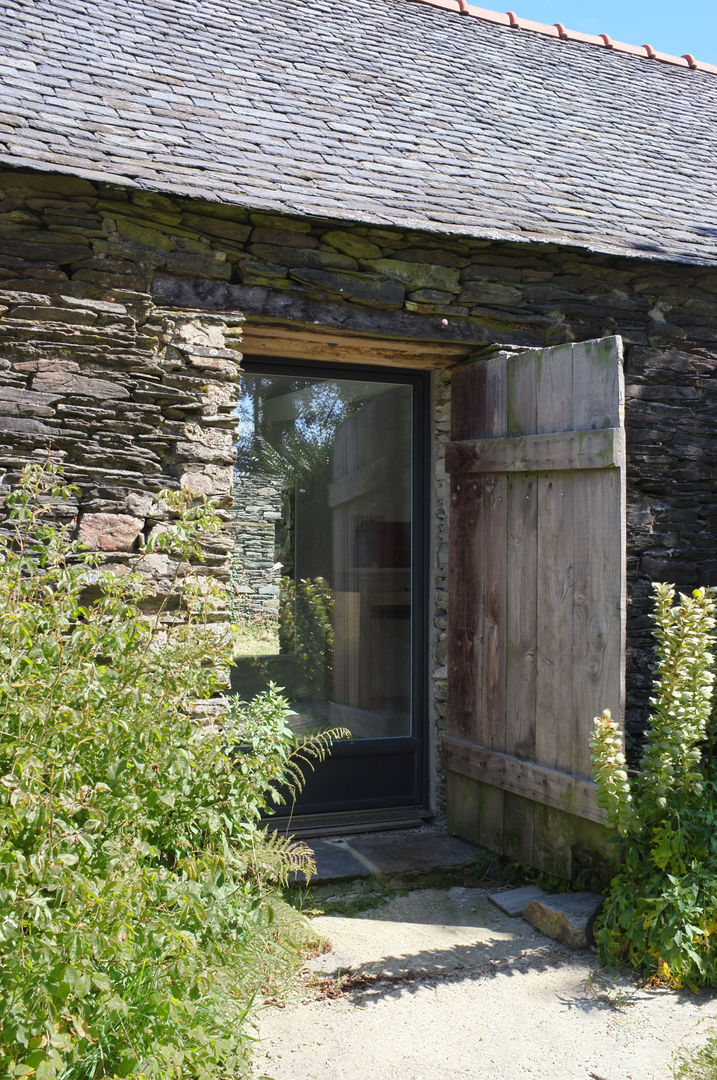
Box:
[446, 428, 625, 473]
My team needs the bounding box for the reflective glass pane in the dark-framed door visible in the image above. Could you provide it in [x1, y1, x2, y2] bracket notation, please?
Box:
[232, 374, 412, 739]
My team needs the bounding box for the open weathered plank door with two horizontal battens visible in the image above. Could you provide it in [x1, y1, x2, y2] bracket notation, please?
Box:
[444, 337, 625, 873]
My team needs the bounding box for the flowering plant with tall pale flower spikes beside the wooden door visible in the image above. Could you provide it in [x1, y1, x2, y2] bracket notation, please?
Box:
[593, 584, 717, 989]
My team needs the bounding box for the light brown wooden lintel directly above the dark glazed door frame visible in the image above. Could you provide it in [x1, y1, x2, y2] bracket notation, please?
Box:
[242, 321, 475, 370]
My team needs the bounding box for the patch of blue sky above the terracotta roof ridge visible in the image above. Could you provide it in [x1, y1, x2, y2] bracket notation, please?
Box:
[507, 0, 717, 65]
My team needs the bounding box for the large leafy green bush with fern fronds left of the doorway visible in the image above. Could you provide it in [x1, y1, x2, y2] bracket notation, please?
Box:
[0, 467, 330, 1080]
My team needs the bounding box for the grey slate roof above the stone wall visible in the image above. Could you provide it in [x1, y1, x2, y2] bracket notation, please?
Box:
[0, 0, 717, 264]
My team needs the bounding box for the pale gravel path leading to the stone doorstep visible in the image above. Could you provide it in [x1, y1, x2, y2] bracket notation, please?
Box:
[256, 888, 717, 1080]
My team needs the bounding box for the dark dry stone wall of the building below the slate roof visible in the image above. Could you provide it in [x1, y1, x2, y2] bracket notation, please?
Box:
[0, 171, 717, 756]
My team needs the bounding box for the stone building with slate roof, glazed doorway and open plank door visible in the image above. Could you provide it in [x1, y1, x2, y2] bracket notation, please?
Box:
[0, 0, 717, 870]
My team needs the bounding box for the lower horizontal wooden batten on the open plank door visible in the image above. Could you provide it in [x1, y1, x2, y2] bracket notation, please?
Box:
[443, 735, 605, 824]
